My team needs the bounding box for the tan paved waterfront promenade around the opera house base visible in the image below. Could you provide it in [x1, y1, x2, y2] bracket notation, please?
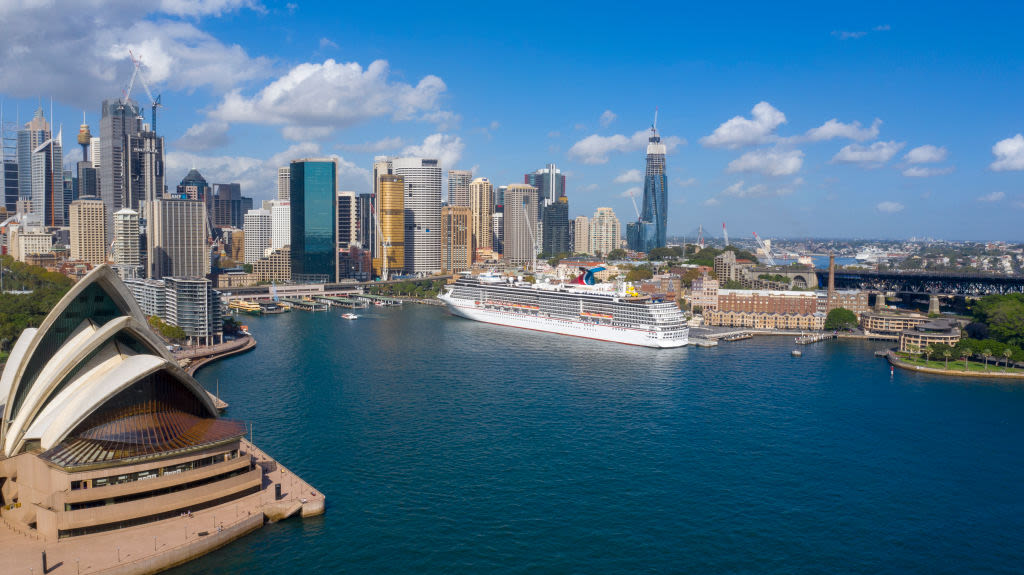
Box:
[0, 439, 327, 575]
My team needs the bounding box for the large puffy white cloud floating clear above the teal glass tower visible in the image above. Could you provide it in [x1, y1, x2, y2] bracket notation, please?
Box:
[210, 58, 452, 139]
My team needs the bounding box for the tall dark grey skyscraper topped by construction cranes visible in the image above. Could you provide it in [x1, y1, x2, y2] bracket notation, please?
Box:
[99, 99, 142, 233]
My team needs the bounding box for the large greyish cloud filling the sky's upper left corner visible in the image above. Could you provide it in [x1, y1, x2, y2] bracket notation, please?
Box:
[0, 0, 269, 108]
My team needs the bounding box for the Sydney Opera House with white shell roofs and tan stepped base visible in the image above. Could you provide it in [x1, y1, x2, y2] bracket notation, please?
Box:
[0, 266, 284, 544]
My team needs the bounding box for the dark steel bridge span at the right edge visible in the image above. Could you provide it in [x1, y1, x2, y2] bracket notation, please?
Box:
[814, 268, 1024, 297]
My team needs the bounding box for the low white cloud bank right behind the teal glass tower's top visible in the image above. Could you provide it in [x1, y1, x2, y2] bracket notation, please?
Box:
[165, 142, 370, 198]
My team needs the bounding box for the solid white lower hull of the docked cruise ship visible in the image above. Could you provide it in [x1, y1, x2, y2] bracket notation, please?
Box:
[438, 295, 689, 349]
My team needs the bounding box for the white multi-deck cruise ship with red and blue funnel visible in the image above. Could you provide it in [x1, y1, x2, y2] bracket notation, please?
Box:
[438, 268, 689, 348]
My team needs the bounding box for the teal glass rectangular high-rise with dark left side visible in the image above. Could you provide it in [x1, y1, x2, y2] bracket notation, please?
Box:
[289, 159, 338, 281]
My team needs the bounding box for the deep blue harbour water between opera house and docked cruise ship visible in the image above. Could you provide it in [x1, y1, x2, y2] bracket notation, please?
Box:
[173, 305, 1024, 575]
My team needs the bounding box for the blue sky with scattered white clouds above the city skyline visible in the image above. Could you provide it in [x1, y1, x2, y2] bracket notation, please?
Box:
[0, 0, 1024, 240]
